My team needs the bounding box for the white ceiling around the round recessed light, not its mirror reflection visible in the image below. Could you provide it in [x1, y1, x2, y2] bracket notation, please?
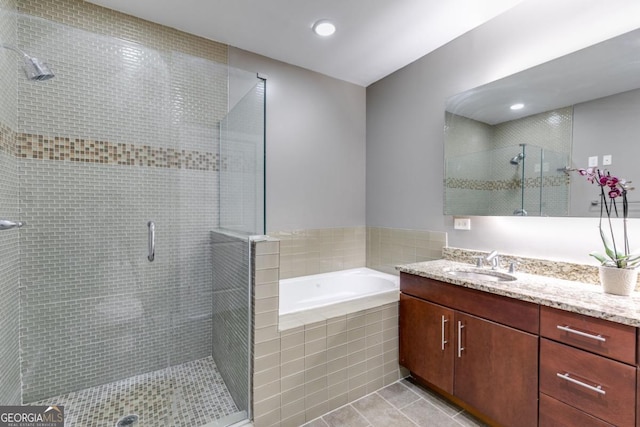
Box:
[89, 0, 522, 86]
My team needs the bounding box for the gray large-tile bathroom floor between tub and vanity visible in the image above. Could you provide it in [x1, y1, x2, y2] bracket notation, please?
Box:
[304, 379, 485, 427]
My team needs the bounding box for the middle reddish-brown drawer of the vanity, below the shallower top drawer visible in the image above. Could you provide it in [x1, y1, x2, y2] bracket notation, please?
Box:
[540, 338, 636, 426]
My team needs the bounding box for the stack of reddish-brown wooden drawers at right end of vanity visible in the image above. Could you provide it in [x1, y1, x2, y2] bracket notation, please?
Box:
[540, 307, 637, 427]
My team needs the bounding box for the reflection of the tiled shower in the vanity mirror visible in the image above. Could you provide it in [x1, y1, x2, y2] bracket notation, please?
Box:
[445, 107, 572, 216]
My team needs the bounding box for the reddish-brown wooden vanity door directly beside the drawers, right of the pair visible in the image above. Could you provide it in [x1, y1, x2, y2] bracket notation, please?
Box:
[453, 312, 538, 427]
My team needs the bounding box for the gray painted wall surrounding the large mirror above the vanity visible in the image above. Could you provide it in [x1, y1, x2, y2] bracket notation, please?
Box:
[366, 0, 640, 263]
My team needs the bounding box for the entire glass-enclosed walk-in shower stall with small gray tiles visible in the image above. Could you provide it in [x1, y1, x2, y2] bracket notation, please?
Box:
[0, 0, 265, 426]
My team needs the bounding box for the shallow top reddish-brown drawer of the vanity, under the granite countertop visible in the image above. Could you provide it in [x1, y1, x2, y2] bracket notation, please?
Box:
[540, 306, 636, 365]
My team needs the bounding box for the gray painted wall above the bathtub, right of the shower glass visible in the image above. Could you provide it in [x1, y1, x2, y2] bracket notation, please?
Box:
[229, 48, 366, 232]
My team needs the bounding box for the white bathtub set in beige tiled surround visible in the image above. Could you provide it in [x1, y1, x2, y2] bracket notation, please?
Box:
[279, 268, 400, 316]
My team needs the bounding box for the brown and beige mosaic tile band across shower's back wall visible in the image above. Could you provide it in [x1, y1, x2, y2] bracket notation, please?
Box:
[16, 133, 220, 171]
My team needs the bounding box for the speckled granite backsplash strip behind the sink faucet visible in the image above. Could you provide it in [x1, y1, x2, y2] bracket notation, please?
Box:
[442, 247, 600, 285]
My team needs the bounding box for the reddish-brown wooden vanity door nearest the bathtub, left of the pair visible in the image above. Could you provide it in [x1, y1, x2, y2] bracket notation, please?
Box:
[399, 294, 455, 394]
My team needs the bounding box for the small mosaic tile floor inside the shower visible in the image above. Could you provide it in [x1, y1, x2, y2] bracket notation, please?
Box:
[31, 357, 238, 427]
